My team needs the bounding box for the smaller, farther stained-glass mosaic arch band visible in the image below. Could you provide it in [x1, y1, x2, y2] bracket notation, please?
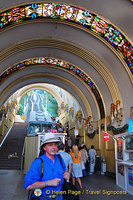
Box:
[0, 57, 105, 118]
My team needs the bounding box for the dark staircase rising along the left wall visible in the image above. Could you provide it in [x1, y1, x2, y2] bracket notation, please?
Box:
[0, 123, 27, 170]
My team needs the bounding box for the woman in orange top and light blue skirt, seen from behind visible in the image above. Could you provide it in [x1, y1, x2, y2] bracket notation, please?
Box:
[70, 145, 83, 189]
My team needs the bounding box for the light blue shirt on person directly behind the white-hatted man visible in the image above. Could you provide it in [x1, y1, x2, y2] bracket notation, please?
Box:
[57, 150, 73, 171]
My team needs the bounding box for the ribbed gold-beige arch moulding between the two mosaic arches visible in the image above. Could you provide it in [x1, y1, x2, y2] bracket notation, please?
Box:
[0, 38, 122, 102]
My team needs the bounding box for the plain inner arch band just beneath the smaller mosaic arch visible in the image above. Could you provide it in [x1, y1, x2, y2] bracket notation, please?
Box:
[1, 72, 95, 120]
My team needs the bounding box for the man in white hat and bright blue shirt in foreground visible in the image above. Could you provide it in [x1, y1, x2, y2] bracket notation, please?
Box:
[24, 133, 70, 200]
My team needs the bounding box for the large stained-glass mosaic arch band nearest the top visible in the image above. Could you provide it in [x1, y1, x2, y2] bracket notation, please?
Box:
[0, 3, 133, 73]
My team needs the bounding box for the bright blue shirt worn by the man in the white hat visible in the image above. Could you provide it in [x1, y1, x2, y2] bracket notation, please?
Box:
[24, 154, 66, 195]
